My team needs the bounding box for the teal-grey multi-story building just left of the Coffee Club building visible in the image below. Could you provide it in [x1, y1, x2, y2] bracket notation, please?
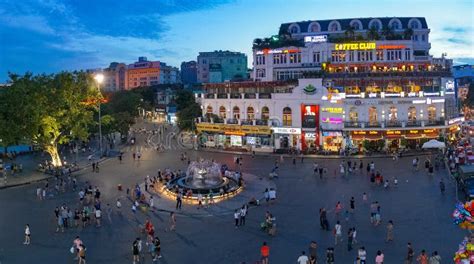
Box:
[197, 50, 247, 83]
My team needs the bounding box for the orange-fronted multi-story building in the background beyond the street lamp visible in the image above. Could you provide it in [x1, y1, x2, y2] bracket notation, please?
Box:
[127, 57, 160, 90]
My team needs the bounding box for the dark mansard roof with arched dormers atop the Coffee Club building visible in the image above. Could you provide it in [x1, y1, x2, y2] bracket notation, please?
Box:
[280, 17, 428, 33]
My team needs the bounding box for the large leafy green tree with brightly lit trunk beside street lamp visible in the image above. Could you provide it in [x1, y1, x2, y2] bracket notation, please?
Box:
[0, 72, 102, 166]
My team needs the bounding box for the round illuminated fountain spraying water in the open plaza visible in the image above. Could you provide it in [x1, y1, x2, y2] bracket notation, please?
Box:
[164, 159, 242, 199]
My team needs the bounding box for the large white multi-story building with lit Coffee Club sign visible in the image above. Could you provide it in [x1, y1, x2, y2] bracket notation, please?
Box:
[198, 18, 460, 151]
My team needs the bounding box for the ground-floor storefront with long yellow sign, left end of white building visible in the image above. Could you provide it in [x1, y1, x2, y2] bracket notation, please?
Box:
[196, 123, 271, 150]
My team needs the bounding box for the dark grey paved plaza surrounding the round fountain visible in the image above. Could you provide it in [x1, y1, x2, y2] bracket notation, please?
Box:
[0, 125, 466, 264]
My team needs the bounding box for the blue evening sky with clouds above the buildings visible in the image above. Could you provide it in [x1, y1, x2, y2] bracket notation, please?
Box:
[0, 0, 474, 82]
